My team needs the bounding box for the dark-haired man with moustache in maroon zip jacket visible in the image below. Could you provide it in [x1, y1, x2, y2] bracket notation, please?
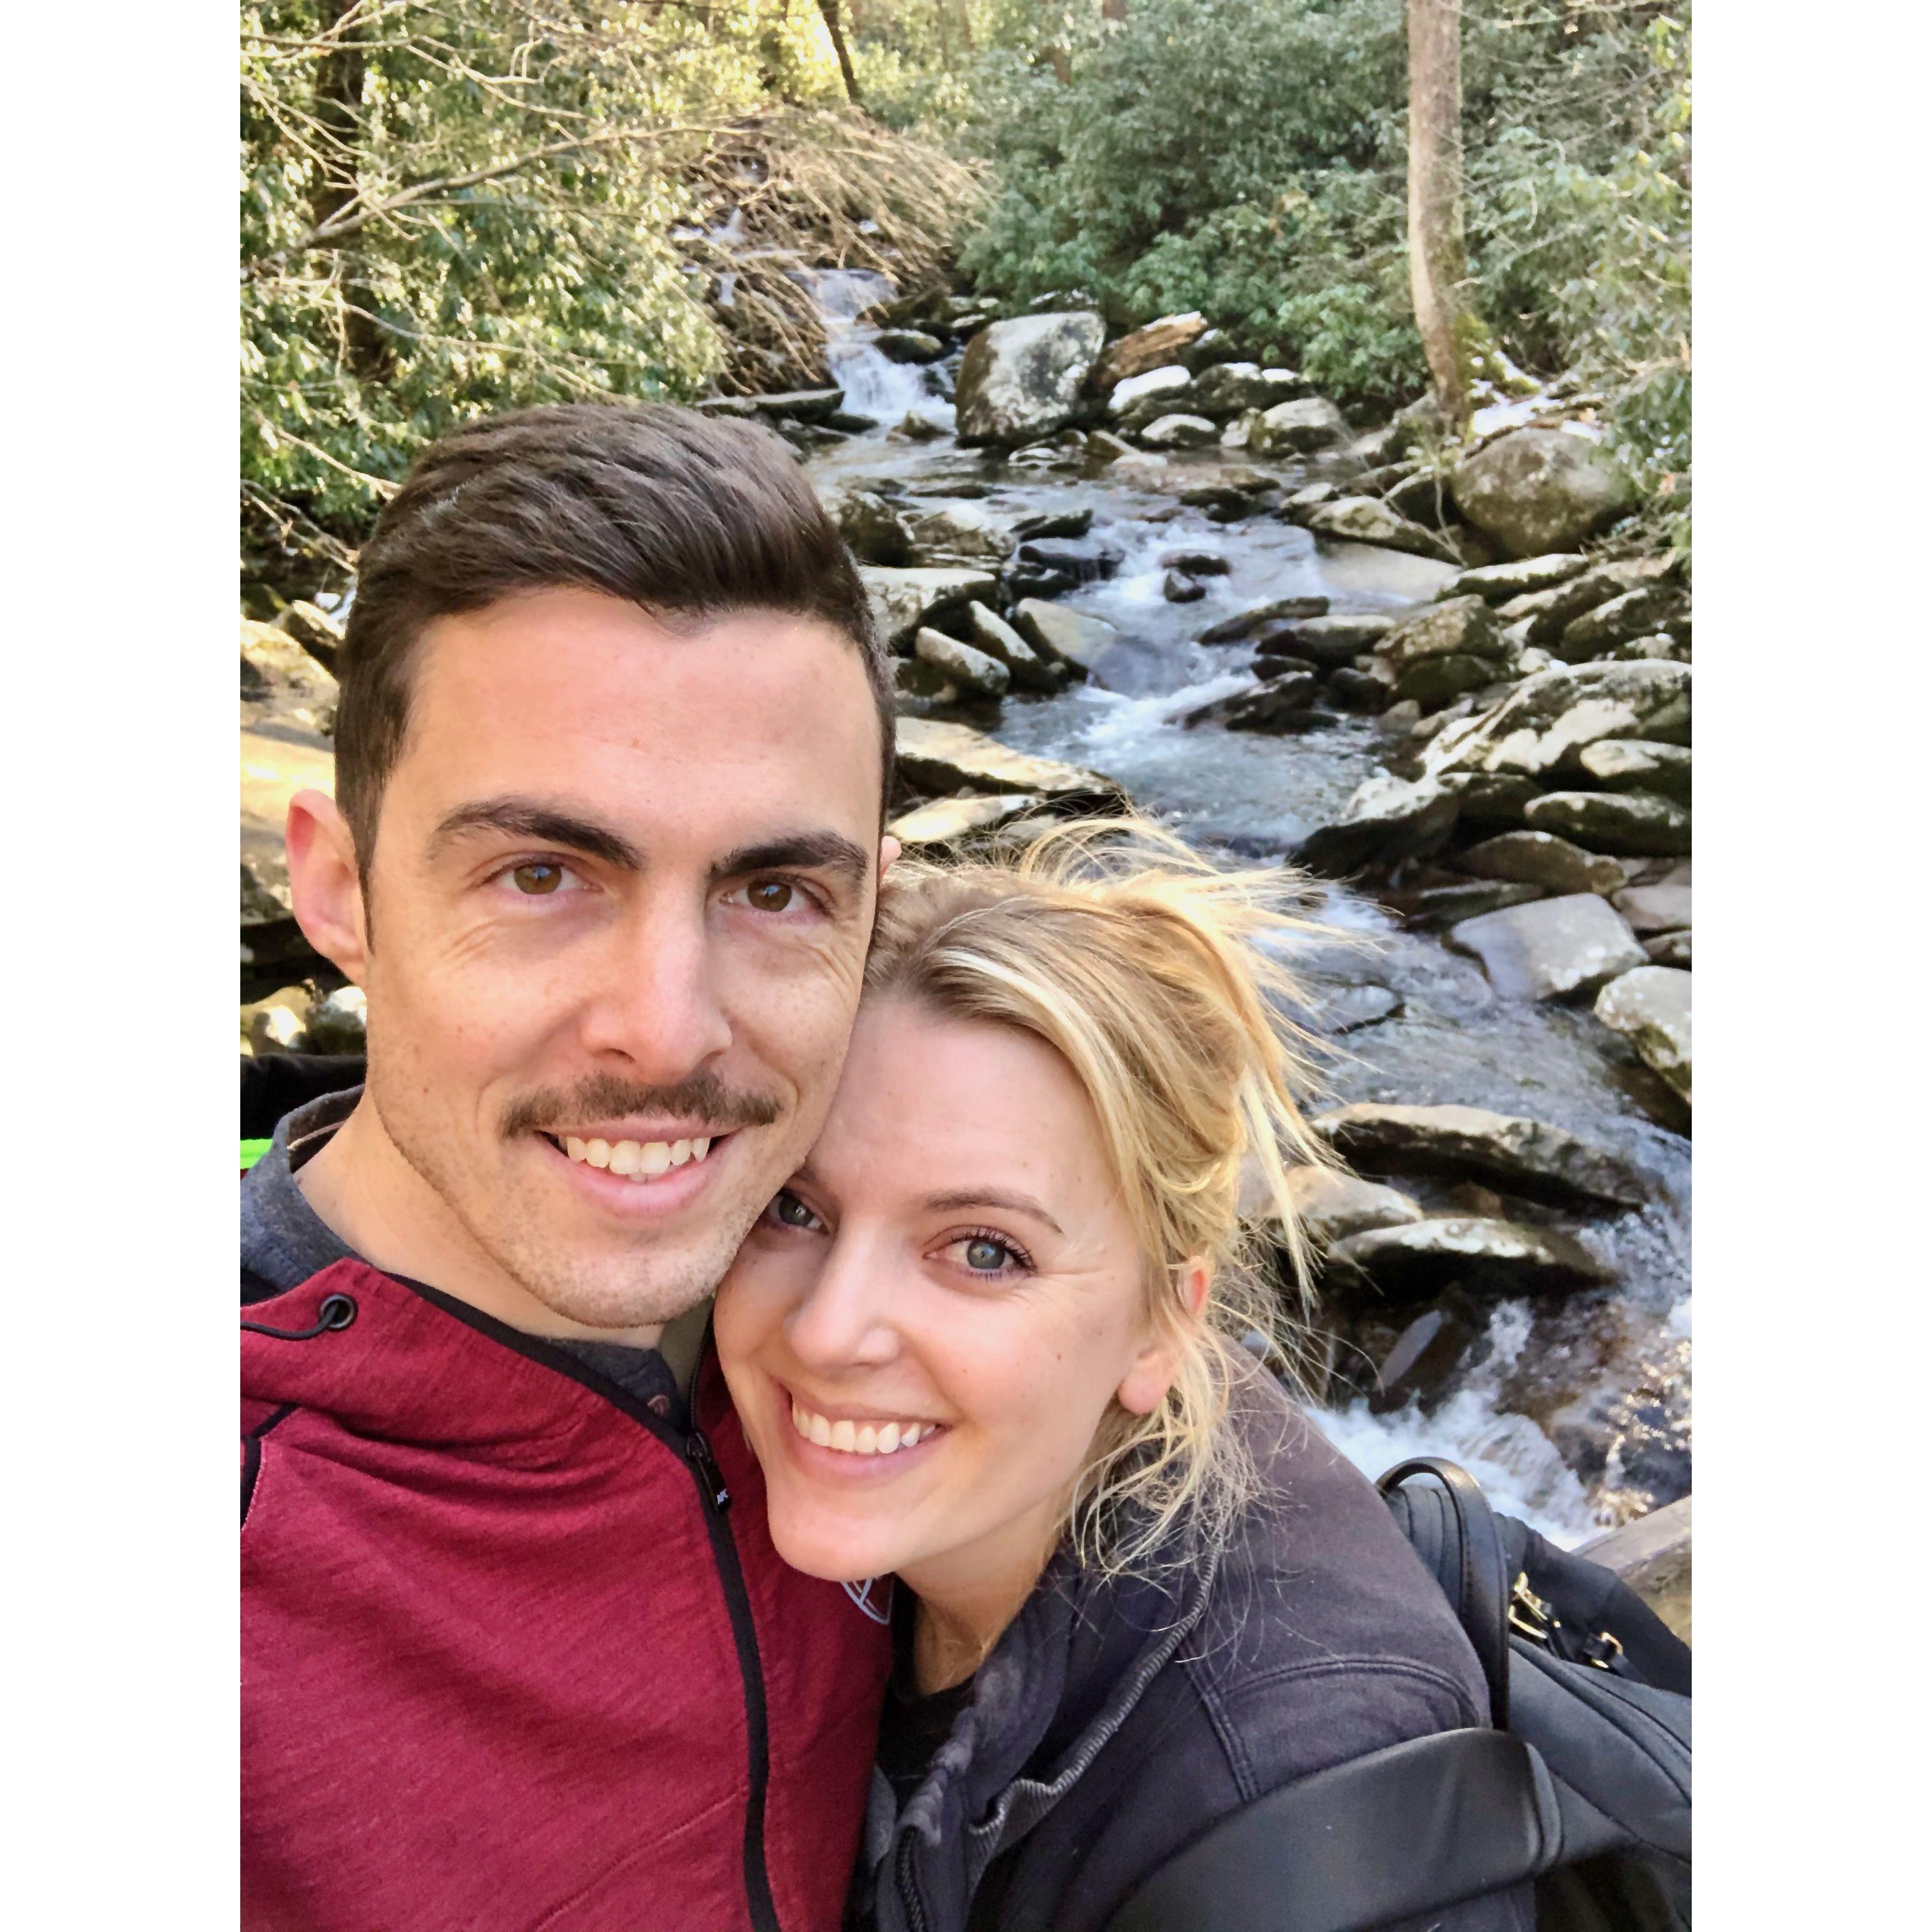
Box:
[242, 405, 895, 1932]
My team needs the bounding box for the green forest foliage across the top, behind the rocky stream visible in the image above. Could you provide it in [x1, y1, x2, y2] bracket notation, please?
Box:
[242, 0, 1690, 570]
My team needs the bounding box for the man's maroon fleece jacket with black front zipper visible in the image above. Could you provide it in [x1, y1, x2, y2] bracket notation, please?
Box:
[242, 1261, 888, 1932]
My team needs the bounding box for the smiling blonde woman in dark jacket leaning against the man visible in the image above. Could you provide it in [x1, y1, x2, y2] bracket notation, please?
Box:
[717, 825, 1528, 1932]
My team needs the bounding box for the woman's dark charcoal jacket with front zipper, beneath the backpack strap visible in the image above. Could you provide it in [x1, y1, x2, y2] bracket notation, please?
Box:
[854, 1378, 1534, 1932]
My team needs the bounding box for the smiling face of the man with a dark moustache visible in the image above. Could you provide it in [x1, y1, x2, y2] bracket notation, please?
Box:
[352, 589, 881, 1327]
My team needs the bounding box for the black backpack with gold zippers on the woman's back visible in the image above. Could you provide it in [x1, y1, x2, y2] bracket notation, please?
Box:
[1107, 1457, 1690, 1932]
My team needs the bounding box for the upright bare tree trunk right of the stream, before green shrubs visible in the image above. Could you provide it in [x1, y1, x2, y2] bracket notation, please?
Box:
[1408, 0, 1468, 431]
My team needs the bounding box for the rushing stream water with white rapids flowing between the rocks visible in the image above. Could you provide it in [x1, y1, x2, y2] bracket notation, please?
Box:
[792, 328, 1690, 1545]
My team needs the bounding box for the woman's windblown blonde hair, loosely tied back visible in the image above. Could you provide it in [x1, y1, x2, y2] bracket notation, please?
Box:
[865, 817, 1331, 1571]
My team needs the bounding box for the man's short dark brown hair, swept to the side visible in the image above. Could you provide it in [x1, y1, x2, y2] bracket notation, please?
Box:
[336, 402, 895, 877]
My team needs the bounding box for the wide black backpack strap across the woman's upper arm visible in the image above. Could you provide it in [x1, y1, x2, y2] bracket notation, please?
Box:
[1107, 1729, 1563, 1932]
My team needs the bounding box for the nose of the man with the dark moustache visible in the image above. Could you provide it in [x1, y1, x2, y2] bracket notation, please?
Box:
[584, 897, 732, 1085]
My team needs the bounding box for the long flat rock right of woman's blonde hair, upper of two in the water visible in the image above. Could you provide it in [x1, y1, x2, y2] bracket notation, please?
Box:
[1312, 1103, 1646, 1208]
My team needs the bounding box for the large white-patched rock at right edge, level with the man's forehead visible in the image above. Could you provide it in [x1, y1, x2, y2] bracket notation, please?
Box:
[1422, 664, 1690, 784]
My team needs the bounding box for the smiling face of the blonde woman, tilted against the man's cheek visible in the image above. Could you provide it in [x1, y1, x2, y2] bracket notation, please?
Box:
[717, 999, 1175, 1594]
